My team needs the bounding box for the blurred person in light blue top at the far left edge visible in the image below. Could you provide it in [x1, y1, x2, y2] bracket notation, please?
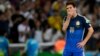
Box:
[0, 29, 9, 56]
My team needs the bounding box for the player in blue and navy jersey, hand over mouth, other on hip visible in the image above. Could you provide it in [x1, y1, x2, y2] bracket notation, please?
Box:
[62, 1, 94, 56]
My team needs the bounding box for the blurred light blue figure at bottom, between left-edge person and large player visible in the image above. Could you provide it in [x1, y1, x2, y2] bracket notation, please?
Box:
[26, 38, 39, 56]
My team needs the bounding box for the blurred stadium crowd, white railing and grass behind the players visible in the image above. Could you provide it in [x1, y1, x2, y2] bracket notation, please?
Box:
[0, 0, 100, 56]
